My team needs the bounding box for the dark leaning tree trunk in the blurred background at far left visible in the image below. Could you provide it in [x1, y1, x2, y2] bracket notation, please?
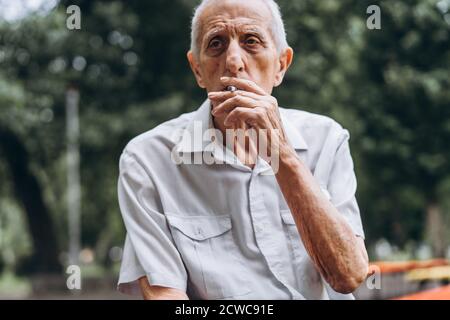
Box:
[0, 127, 61, 273]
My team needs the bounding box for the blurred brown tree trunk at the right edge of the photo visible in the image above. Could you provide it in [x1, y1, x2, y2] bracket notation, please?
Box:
[426, 202, 446, 258]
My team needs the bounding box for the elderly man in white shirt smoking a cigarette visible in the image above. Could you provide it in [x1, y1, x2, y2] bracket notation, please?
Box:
[118, 0, 368, 299]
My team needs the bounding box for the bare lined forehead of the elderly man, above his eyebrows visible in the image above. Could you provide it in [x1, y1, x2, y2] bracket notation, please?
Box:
[199, 0, 272, 35]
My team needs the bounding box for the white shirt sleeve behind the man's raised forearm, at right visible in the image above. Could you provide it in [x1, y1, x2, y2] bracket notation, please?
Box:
[327, 129, 365, 239]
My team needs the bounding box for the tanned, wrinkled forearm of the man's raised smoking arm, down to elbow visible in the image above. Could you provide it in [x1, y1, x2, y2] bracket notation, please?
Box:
[276, 147, 368, 293]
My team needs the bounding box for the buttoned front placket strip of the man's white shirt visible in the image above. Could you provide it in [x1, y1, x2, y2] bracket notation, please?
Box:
[249, 159, 305, 300]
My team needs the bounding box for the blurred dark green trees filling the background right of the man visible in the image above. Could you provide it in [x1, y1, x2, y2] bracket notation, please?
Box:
[278, 0, 450, 256]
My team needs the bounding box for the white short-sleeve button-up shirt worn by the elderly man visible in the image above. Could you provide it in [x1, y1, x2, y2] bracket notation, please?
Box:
[118, 100, 364, 299]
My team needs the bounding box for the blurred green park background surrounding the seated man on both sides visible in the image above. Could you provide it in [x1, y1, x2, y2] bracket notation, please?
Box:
[0, 0, 450, 299]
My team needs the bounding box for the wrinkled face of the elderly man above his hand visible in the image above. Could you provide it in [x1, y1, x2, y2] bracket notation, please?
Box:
[188, 0, 285, 94]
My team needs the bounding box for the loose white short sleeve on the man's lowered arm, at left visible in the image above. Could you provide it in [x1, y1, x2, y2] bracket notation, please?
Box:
[118, 151, 187, 294]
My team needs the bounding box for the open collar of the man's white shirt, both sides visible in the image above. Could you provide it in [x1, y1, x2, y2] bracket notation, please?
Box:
[178, 99, 308, 153]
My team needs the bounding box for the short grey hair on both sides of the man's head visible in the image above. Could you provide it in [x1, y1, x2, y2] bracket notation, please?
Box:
[191, 0, 288, 58]
